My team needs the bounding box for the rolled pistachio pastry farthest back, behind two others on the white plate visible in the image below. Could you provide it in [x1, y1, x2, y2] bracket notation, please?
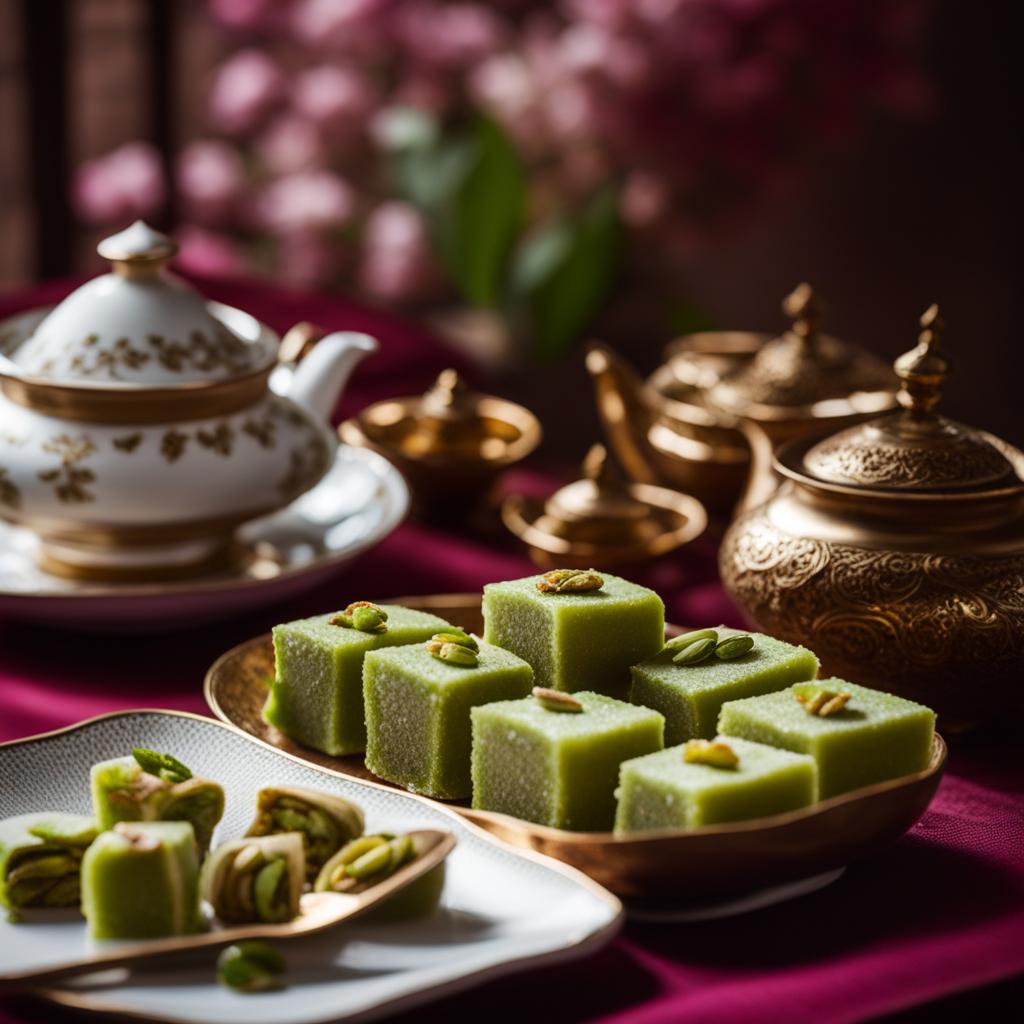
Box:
[246, 786, 364, 881]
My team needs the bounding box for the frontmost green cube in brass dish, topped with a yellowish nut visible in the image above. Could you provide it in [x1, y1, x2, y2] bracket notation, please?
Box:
[615, 736, 816, 833]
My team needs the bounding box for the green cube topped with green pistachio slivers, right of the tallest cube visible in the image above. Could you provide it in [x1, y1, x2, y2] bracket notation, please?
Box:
[630, 626, 818, 745]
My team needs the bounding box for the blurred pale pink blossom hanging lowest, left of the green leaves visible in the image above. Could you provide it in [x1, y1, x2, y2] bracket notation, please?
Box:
[358, 200, 437, 300]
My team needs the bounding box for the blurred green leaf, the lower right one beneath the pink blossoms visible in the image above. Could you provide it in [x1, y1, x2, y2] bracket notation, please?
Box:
[512, 186, 620, 360]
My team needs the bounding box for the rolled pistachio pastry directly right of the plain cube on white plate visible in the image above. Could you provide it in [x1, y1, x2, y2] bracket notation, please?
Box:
[200, 831, 306, 925]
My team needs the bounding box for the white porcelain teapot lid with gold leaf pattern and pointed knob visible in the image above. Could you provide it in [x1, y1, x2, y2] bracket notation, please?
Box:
[10, 220, 276, 388]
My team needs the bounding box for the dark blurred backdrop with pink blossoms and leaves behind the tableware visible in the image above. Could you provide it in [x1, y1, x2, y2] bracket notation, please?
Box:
[0, 0, 1024, 451]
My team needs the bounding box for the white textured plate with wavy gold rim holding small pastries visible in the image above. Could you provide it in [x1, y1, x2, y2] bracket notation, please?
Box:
[0, 711, 622, 1024]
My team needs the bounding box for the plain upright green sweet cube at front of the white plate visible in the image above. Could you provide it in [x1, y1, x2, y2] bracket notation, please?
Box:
[82, 821, 200, 939]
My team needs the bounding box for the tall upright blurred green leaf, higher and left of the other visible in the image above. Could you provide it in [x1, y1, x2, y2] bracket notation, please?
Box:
[434, 119, 526, 306]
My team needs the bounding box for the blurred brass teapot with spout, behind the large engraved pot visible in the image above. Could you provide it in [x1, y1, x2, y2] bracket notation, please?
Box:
[587, 284, 895, 519]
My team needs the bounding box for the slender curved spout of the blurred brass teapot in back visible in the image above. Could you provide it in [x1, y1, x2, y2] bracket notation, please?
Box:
[586, 342, 658, 483]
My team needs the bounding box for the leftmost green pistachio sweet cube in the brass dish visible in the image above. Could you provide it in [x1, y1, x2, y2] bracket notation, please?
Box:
[263, 604, 449, 755]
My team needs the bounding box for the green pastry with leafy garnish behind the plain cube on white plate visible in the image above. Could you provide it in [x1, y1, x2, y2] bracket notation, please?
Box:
[92, 755, 224, 857]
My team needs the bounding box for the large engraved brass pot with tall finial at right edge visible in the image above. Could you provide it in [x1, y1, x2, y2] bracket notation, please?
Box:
[720, 306, 1024, 730]
